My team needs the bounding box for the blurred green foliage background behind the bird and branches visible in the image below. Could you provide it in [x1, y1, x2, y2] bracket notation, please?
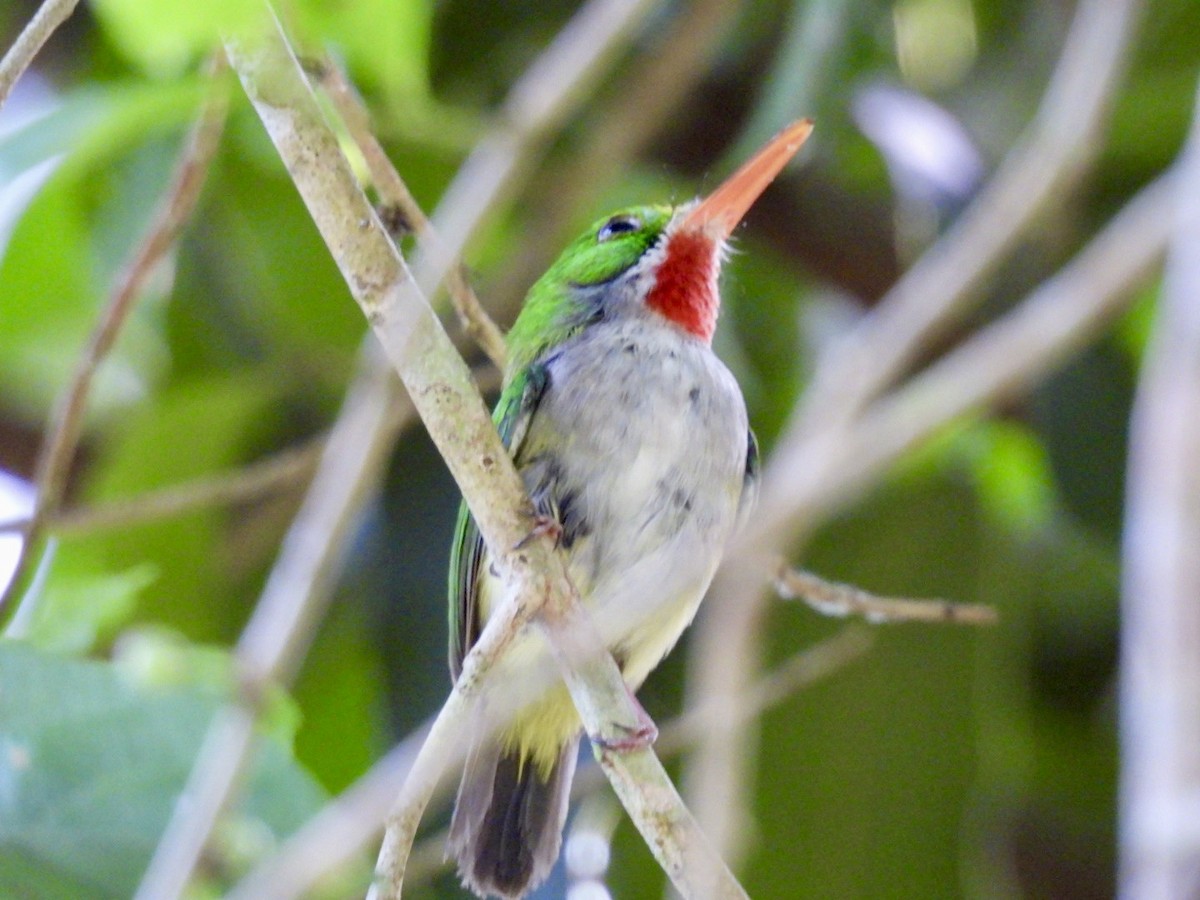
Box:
[0, 0, 1200, 898]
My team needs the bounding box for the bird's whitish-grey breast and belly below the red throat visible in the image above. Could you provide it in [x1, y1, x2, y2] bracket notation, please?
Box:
[480, 319, 748, 688]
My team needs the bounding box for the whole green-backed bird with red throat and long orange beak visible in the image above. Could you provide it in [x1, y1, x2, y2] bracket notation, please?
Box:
[450, 120, 812, 898]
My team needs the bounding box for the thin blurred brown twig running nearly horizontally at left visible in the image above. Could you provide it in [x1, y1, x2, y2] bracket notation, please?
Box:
[0, 437, 324, 535]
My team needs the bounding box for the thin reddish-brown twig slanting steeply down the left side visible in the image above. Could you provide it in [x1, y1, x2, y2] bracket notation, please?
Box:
[0, 58, 228, 619]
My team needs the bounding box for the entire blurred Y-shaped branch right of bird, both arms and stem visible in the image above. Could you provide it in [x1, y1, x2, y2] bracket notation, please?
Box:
[688, 0, 1165, 860]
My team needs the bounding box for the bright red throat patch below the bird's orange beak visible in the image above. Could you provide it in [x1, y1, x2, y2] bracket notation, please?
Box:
[646, 230, 721, 343]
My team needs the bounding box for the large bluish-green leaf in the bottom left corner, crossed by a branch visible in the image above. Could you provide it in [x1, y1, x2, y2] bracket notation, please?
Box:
[0, 642, 324, 900]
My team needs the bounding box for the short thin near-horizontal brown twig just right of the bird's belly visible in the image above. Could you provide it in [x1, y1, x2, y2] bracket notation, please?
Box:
[775, 560, 997, 625]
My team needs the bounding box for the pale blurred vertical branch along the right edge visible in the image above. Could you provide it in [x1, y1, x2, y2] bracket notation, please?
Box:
[1120, 79, 1200, 900]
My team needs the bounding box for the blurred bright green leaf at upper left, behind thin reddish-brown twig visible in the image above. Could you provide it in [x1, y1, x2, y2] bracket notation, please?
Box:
[0, 76, 199, 419]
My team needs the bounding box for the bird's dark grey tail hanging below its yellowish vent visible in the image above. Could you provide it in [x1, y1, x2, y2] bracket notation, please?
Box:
[449, 734, 580, 899]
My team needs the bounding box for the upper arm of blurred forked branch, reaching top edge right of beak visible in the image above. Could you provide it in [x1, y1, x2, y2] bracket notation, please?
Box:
[798, 0, 1142, 432]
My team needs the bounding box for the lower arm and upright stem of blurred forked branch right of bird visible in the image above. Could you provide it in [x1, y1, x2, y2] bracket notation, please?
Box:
[690, 142, 1178, 873]
